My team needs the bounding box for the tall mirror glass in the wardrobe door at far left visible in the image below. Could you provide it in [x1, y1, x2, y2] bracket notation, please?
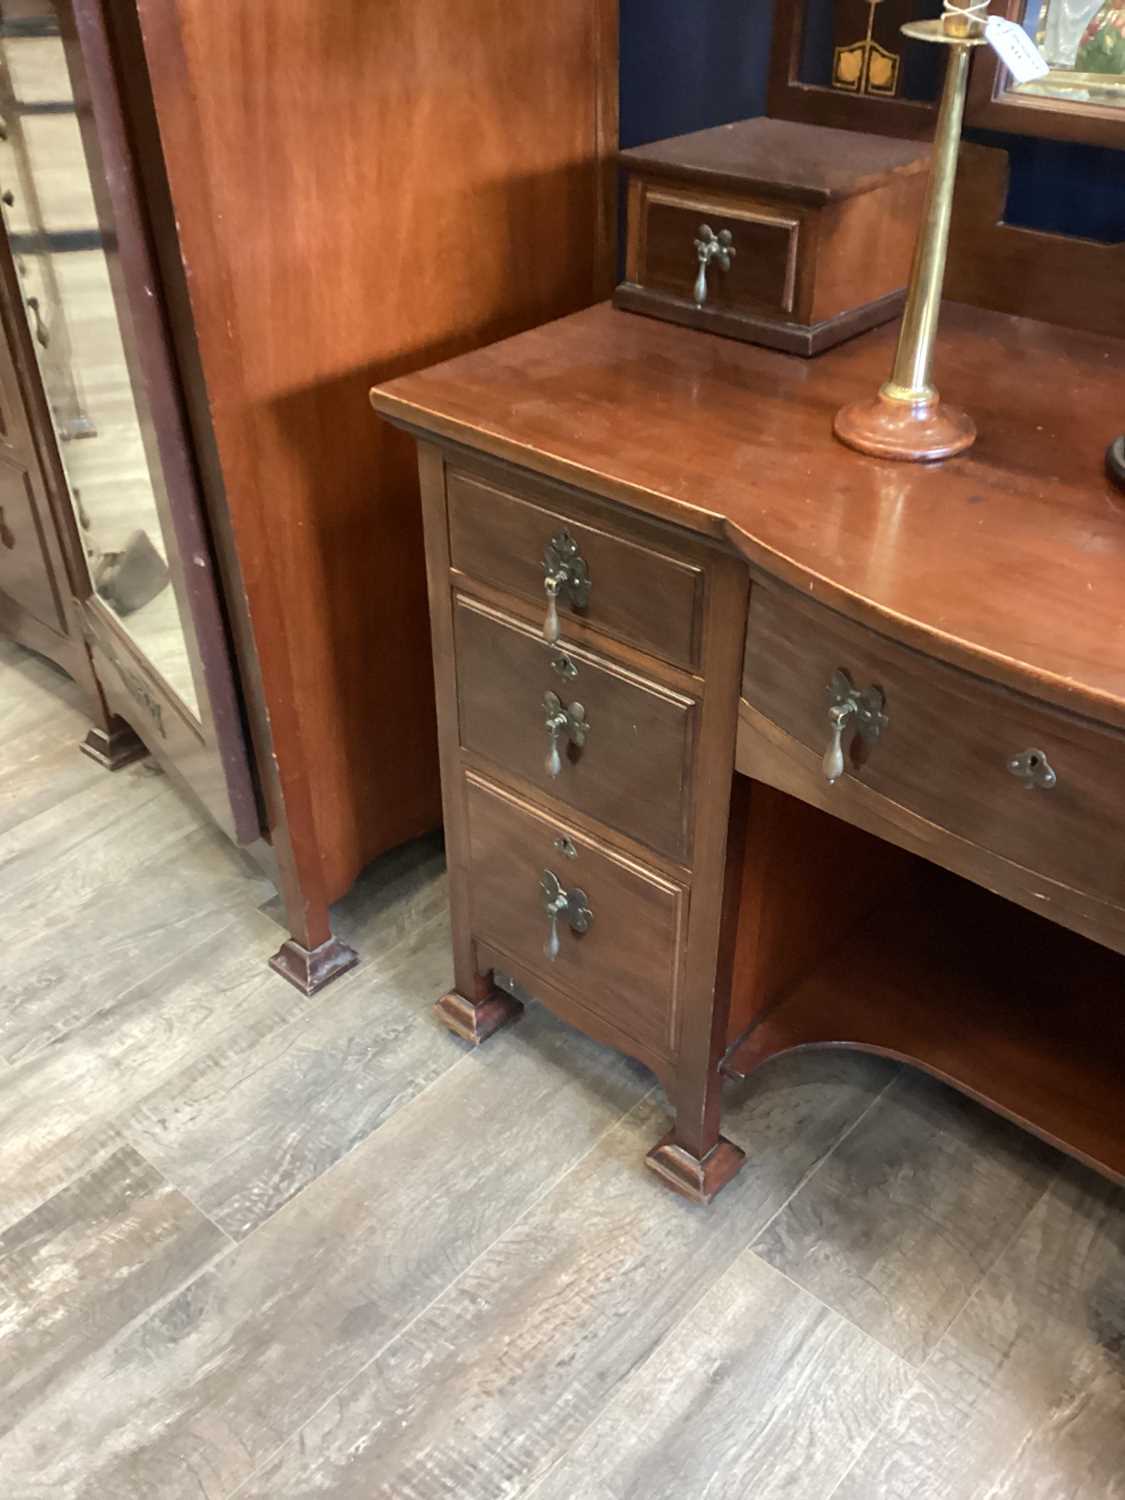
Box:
[0, 0, 200, 717]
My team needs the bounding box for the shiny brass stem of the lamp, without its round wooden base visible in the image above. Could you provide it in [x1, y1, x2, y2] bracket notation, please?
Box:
[884, 45, 969, 402]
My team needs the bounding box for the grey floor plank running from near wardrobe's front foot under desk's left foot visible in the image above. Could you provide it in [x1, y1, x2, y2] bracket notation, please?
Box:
[122, 878, 461, 1239]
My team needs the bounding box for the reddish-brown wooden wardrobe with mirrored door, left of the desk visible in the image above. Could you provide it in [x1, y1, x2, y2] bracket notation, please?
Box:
[0, 0, 618, 992]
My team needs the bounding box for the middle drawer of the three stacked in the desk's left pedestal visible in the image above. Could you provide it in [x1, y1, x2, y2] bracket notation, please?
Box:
[453, 596, 698, 861]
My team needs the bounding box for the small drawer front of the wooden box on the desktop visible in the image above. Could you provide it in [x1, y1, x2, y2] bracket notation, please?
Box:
[636, 188, 801, 318]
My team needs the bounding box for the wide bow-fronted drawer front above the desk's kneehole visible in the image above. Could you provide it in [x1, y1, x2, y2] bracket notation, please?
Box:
[743, 587, 1125, 905]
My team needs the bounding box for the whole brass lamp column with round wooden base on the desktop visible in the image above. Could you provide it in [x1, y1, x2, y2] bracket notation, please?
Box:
[836, 0, 987, 462]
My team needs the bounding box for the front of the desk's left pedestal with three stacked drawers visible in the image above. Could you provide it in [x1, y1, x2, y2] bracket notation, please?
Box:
[423, 450, 747, 1079]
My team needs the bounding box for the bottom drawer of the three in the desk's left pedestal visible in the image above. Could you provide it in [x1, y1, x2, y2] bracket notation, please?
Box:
[465, 773, 687, 1056]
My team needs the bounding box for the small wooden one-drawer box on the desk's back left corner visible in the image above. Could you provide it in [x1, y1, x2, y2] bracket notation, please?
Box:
[614, 120, 930, 354]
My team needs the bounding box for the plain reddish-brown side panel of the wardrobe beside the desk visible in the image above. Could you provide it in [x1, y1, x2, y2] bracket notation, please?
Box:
[138, 0, 617, 900]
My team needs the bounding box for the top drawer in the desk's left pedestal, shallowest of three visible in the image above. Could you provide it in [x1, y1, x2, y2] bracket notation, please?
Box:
[449, 473, 705, 668]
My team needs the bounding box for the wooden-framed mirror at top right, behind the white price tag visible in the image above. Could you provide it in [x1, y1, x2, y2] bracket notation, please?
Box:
[966, 0, 1125, 149]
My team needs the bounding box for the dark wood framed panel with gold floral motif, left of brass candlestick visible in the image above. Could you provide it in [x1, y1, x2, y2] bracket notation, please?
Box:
[768, 0, 948, 137]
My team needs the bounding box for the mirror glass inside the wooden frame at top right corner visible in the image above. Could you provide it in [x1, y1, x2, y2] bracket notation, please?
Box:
[1014, 0, 1125, 108]
